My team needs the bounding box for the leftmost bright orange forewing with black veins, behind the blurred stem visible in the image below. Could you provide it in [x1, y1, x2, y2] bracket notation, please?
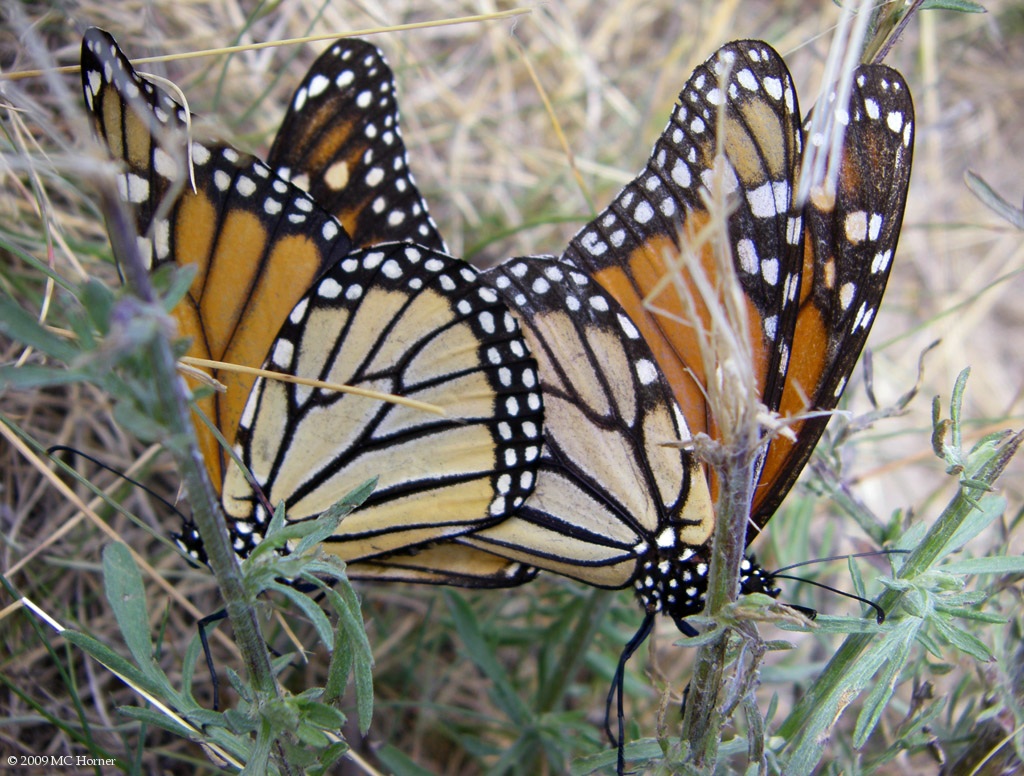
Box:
[82, 29, 350, 486]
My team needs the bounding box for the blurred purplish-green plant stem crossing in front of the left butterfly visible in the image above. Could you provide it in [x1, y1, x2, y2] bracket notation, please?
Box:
[100, 186, 287, 768]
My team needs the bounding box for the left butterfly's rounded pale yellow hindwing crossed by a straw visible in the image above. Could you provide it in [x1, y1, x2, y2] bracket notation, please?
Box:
[204, 244, 543, 560]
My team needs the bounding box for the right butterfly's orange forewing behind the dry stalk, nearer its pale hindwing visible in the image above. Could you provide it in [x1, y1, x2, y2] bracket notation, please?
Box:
[565, 41, 801, 450]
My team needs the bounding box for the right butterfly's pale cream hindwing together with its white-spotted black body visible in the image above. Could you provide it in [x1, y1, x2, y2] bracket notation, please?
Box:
[460, 258, 737, 619]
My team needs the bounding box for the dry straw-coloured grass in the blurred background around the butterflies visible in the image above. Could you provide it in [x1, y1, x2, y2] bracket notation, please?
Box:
[0, 0, 1024, 773]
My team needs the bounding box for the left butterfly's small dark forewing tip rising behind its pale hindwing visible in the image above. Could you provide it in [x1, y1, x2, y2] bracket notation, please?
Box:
[267, 38, 446, 253]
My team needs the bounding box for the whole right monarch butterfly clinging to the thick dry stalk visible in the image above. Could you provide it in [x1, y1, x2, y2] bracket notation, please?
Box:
[333, 41, 913, 771]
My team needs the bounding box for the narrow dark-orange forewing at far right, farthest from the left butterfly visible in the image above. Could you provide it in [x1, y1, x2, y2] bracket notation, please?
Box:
[753, 64, 914, 526]
